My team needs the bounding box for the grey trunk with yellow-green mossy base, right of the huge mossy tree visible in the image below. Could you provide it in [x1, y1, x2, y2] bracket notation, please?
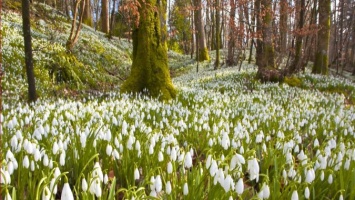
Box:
[193, 0, 210, 61]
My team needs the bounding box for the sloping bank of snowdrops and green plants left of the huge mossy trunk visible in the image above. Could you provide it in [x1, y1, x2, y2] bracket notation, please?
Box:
[2, 4, 135, 99]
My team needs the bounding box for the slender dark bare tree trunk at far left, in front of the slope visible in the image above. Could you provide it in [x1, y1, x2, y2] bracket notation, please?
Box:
[22, 0, 37, 102]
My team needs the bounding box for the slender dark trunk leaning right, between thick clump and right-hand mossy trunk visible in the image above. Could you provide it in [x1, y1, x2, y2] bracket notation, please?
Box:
[289, 0, 306, 74]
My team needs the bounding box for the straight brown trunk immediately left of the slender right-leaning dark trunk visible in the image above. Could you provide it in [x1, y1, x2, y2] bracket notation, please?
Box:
[279, 0, 288, 54]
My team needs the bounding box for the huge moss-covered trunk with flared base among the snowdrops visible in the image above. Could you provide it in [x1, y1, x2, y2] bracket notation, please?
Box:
[121, 0, 176, 100]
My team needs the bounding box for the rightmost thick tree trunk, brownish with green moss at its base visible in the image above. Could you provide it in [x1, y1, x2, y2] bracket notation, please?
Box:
[312, 0, 331, 74]
